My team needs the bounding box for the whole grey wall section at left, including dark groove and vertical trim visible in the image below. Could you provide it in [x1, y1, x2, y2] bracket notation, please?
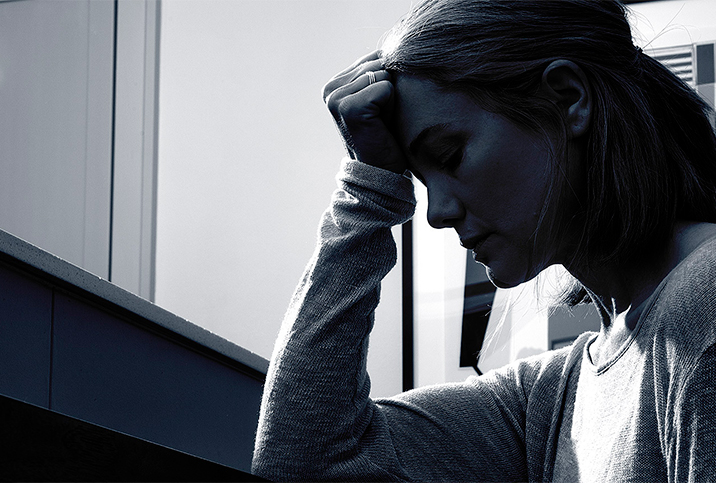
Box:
[0, 0, 158, 300]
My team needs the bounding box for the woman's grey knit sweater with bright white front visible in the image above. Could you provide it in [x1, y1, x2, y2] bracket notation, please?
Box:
[253, 160, 716, 482]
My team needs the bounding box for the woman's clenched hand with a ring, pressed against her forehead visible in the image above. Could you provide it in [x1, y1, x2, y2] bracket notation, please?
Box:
[323, 51, 407, 174]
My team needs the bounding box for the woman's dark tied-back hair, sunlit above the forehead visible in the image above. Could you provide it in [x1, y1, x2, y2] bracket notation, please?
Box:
[382, 0, 716, 302]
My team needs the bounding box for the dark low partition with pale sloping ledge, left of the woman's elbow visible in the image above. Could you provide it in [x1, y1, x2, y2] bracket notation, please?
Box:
[0, 231, 268, 475]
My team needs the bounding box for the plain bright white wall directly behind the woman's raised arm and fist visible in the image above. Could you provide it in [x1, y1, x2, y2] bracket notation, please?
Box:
[156, 0, 411, 395]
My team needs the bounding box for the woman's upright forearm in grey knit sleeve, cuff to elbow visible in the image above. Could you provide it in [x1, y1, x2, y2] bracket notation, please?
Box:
[254, 161, 414, 480]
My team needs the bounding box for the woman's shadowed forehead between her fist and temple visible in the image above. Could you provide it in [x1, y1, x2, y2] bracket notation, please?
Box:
[393, 75, 480, 151]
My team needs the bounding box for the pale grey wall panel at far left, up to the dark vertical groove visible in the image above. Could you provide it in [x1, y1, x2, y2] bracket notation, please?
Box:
[0, 0, 114, 277]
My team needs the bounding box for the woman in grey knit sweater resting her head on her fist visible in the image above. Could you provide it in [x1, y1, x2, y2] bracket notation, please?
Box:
[254, 0, 716, 482]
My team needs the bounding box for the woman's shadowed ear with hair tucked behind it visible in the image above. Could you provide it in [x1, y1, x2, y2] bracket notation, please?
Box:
[540, 59, 592, 139]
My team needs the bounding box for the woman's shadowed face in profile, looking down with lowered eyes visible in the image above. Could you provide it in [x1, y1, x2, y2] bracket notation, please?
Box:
[393, 75, 572, 287]
